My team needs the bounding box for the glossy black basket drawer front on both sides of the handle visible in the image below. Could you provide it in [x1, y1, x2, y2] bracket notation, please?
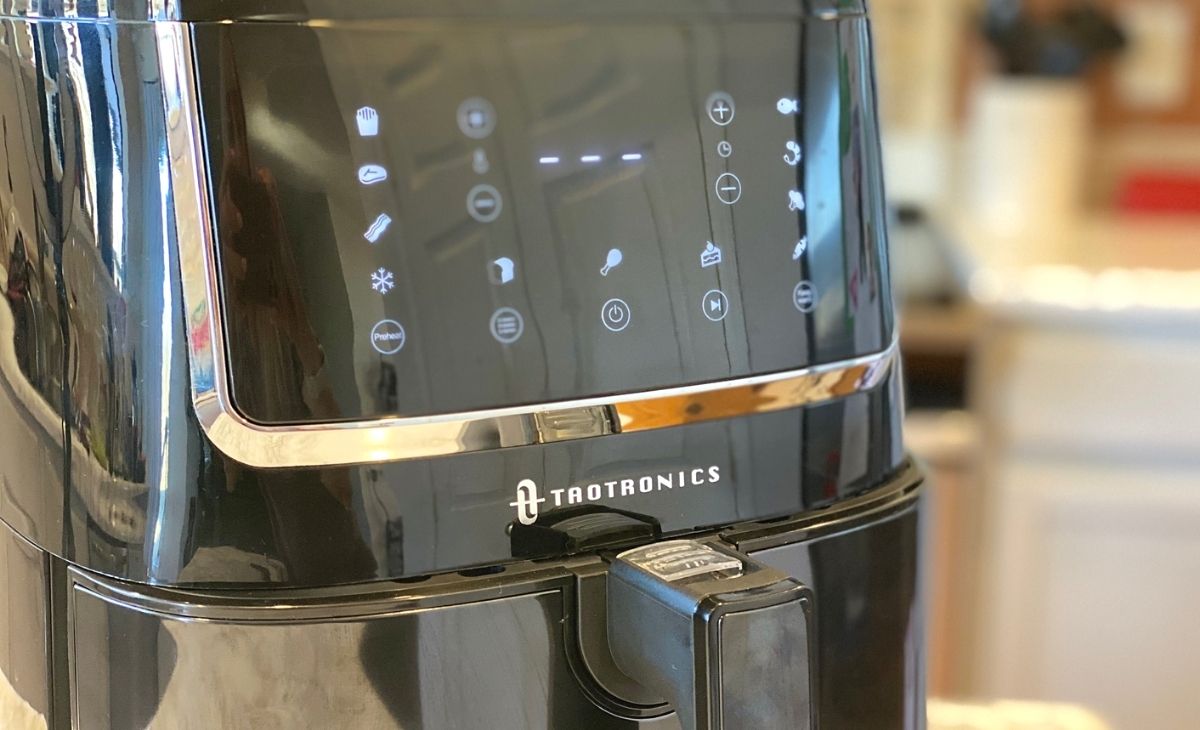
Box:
[71, 475, 923, 730]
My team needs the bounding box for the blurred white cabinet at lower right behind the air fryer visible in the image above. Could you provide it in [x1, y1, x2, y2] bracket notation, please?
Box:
[970, 317, 1200, 730]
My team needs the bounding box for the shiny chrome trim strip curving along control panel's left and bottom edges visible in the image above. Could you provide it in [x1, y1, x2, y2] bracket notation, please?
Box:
[156, 23, 898, 468]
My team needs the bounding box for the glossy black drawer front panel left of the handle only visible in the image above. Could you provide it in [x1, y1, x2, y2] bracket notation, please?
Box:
[73, 581, 628, 730]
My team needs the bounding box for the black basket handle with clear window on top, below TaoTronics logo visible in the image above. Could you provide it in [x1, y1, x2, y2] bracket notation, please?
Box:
[608, 540, 815, 730]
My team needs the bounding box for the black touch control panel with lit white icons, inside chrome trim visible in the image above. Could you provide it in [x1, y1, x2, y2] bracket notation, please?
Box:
[196, 19, 890, 423]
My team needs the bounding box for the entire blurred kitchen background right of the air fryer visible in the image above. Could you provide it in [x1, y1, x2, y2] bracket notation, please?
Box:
[871, 0, 1200, 730]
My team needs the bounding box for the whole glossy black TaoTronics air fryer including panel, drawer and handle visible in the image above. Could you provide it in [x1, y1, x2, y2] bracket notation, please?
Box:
[0, 0, 924, 730]
